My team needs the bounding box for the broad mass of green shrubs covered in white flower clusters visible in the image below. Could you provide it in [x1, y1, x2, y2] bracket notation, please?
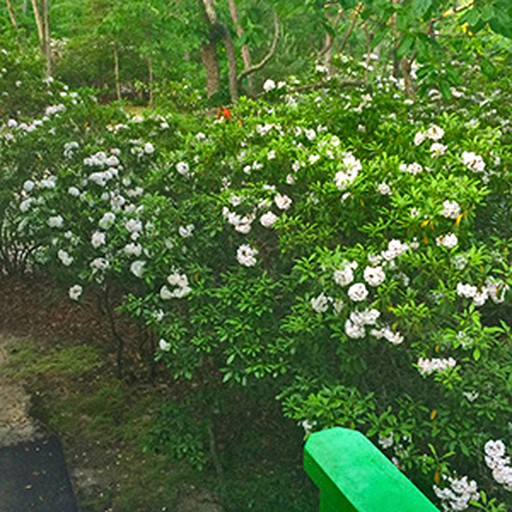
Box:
[0, 55, 512, 510]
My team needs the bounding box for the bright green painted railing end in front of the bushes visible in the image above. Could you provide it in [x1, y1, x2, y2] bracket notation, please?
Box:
[304, 428, 439, 512]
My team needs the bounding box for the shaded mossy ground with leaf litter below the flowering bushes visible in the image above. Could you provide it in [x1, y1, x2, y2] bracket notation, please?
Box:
[0, 276, 316, 512]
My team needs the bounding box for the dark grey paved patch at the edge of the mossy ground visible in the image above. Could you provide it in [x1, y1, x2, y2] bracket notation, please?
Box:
[0, 437, 78, 512]
